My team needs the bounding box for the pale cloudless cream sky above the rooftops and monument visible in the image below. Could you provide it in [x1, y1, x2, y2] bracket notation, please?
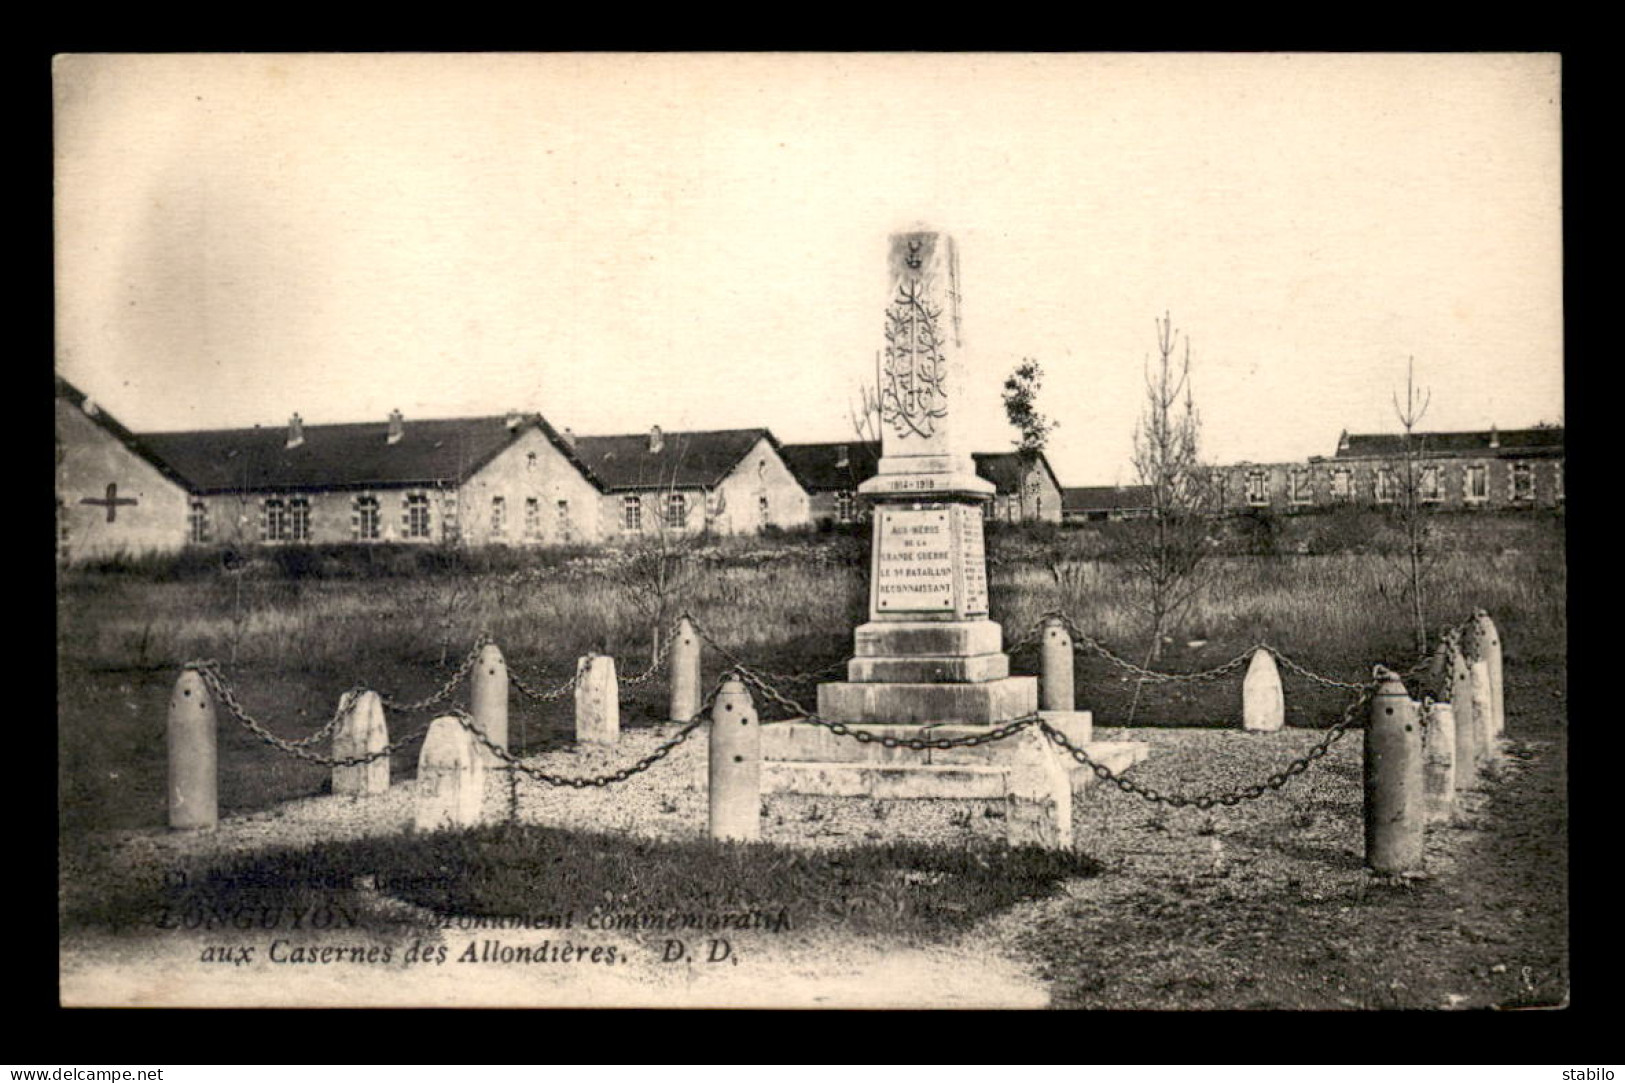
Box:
[54, 54, 1563, 485]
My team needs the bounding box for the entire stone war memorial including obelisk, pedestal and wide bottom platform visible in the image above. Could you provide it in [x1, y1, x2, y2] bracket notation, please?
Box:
[744, 222, 1147, 849]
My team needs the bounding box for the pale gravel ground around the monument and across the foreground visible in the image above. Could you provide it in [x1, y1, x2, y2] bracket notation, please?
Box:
[62, 686, 1568, 1008]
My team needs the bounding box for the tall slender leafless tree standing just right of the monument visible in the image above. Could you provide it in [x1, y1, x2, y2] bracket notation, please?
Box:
[1121, 314, 1216, 665]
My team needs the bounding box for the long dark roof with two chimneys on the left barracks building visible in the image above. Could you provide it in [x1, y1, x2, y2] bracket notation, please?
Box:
[138, 413, 603, 493]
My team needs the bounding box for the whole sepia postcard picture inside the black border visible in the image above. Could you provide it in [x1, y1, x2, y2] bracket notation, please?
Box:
[50, 52, 1573, 1008]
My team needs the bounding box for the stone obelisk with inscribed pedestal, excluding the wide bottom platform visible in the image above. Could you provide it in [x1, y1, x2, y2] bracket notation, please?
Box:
[817, 233, 1038, 725]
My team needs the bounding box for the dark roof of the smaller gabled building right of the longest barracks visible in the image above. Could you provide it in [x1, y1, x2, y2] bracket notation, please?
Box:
[575, 429, 780, 489]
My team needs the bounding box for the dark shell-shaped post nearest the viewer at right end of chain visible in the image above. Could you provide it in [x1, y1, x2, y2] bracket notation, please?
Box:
[1365, 673, 1427, 875]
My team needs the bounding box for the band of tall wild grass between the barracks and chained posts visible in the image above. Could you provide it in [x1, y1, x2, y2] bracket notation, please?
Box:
[57, 515, 1567, 678]
